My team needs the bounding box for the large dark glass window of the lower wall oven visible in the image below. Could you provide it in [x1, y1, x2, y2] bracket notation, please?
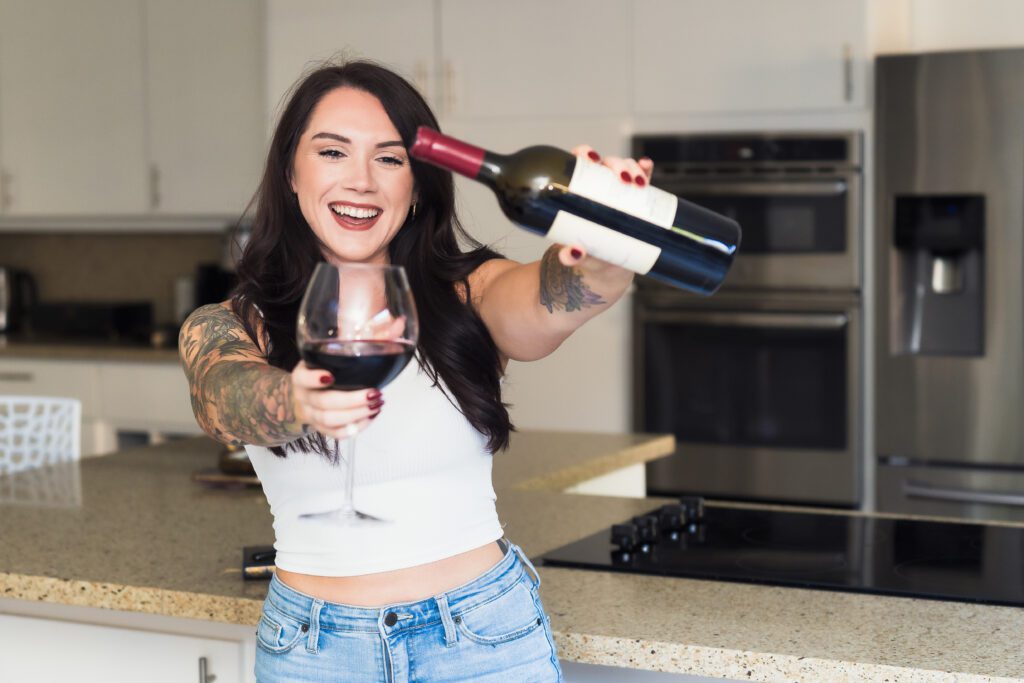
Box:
[643, 319, 849, 452]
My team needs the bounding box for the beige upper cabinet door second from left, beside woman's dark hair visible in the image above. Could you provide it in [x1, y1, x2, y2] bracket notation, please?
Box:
[144, 0, 266, 215]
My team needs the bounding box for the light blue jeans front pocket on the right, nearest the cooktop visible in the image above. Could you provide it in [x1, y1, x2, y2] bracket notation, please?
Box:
[452, 582, 544, 645]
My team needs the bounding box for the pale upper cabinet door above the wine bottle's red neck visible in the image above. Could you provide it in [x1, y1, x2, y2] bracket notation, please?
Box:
[440, 0, 630, 119]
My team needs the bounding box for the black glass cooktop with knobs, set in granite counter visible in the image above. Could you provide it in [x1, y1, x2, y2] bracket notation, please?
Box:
[542, 500, 1024, 606]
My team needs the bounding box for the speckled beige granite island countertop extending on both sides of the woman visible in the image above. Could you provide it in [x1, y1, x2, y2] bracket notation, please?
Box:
[0, 432, 1024, 683]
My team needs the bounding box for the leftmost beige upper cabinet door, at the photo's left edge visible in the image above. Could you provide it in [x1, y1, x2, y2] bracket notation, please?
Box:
[0, 0, 147, 215]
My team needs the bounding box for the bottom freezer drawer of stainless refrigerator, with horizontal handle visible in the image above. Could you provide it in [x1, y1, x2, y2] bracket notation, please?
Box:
[877, 462, 1024, 522]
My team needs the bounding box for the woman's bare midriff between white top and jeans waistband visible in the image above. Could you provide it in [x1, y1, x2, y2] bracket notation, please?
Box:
[276, 543, 504, 607]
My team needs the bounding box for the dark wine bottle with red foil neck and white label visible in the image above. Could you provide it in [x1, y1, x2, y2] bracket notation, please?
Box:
[410, 126, 740, 295]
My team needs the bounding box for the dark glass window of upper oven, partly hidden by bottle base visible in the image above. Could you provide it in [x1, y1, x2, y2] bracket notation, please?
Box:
[680, 189, 848, 254]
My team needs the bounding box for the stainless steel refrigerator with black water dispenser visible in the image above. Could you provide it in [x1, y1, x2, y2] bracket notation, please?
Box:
[874, 49, 1024, 520]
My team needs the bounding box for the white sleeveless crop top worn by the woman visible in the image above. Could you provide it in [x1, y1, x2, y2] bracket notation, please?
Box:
[246, 359, 502, 577]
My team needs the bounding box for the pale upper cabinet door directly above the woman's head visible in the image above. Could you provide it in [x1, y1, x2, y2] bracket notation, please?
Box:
[266, 0, 436, 119]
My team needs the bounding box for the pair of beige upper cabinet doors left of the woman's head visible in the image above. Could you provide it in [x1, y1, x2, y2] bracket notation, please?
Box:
[0, 0, 266, 219]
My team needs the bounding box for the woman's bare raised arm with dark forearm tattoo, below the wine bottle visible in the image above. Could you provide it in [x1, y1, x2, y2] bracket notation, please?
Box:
[469, 245, 633, 360]
